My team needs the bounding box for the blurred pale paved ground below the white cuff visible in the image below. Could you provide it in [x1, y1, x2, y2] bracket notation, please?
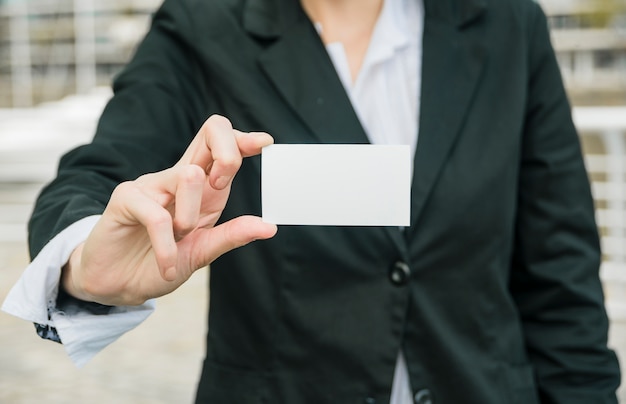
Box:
[0, 237, 626, 404]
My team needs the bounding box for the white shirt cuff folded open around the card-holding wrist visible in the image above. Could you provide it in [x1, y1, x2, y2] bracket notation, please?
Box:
[2, 216, 155, 367]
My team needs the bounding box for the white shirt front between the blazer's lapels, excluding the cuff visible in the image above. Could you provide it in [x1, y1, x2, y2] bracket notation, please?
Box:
[317, 0, 424, 404]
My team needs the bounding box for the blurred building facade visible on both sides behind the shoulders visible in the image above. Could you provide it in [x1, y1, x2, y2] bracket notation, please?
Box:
[0, 0, 626, 107]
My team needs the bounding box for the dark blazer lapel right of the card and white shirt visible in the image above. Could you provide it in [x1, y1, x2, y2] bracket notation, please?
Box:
[411, 0, 486, 232]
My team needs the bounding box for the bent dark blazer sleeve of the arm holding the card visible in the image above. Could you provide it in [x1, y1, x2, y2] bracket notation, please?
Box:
[29, 0, 209, 257]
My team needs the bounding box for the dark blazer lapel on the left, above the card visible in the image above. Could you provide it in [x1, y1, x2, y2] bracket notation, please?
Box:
[244, 0, 368, 147]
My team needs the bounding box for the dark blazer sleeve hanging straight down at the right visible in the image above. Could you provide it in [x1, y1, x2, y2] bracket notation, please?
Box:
[510, 2, 620, 404]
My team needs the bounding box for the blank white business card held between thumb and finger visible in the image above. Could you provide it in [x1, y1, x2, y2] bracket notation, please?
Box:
[261, 144, 411, 226]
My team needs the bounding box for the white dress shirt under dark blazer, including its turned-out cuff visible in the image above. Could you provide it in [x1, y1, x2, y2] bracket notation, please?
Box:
[2, 0, 424, 404]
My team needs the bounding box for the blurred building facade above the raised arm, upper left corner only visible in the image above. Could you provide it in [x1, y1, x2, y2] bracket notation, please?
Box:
[0, 0, 162, 107]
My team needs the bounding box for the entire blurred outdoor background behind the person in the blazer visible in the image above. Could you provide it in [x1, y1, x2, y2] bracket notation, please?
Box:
[0, 0, 626, 404]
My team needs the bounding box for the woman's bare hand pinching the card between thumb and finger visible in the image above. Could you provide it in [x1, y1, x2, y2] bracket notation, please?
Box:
[61, 115, 277, 306]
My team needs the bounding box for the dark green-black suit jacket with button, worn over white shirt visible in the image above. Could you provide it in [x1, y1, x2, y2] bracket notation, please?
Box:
[30, 0, 619, 404]
